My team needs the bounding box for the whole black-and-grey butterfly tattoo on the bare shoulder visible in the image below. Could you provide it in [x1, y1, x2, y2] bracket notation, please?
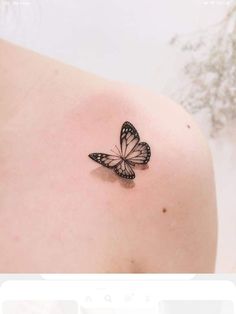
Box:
[89, 121, 151, 180]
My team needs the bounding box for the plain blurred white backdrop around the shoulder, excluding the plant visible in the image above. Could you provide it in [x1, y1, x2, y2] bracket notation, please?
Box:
[0, 0, 236, 272]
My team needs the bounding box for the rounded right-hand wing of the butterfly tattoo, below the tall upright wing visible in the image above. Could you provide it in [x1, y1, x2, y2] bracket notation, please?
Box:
[126, 142, 151, 166]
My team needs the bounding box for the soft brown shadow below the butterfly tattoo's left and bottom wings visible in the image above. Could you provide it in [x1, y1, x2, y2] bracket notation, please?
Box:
[91, 167, 135, 189]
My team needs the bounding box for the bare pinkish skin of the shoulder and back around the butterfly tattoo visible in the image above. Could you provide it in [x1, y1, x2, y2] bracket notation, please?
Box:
[0, 40, 217, 273]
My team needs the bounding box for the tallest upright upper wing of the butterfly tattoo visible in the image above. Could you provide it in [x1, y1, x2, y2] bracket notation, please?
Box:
[120, 121, 140, 158]
